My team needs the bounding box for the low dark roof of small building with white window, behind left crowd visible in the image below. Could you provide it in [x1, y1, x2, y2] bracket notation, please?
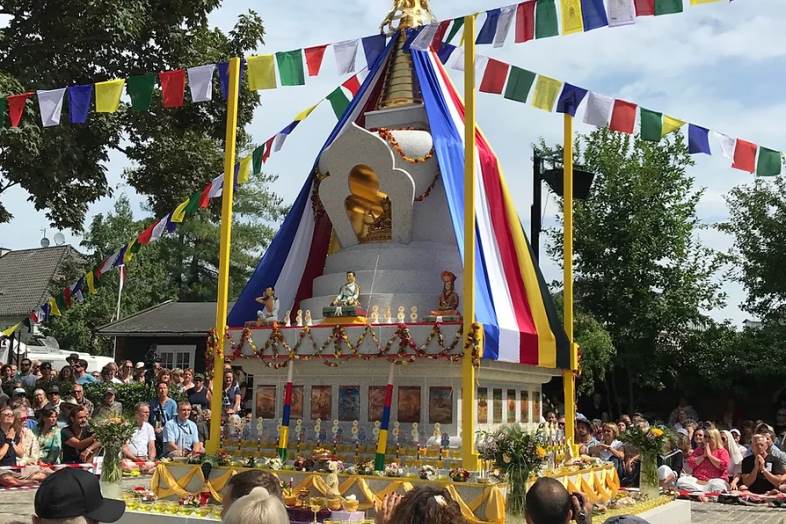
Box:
[96, 300, 232, 337]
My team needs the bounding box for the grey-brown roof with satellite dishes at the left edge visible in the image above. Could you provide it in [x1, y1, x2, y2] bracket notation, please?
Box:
[0, 245, 83, 319]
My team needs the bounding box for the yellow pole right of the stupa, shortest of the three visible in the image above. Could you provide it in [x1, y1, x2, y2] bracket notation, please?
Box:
[562, 113, 578, 444]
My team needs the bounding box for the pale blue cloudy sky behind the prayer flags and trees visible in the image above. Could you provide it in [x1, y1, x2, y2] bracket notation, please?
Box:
[0, 0, 786, 325]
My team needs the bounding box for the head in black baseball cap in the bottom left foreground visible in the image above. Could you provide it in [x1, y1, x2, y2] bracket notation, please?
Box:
[33, 468, 126, 524]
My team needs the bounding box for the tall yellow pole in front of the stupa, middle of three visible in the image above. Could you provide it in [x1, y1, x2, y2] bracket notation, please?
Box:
[461, 15, 478, 471]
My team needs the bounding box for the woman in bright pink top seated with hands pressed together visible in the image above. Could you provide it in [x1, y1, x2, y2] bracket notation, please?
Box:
[677, 428, 729, 492]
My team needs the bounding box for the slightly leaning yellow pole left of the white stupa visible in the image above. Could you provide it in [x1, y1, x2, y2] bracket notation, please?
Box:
[205, 58, 240, 455]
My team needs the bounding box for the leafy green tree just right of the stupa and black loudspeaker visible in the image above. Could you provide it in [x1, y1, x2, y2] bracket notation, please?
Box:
[546, 129, 723, 407]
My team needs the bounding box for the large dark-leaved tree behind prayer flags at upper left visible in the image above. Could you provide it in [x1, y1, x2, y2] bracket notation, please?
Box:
[0, 0, 264, 231]
